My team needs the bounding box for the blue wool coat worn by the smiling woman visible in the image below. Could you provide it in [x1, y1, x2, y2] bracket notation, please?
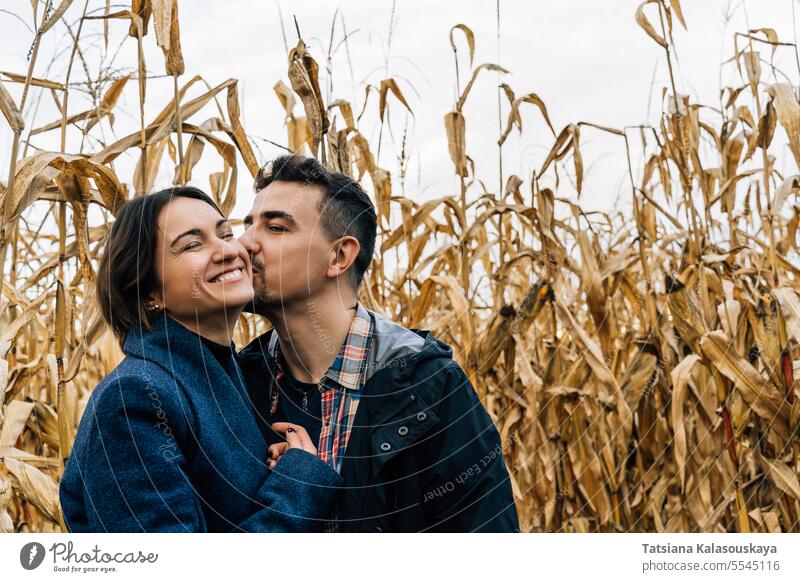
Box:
[60, 315, 341, 532]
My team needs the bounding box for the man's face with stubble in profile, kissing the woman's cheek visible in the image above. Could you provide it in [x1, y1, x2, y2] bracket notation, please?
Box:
[239, 181, 333, 315]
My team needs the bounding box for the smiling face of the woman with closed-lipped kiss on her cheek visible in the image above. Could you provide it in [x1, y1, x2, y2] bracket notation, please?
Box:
[152, 197, 253, 325]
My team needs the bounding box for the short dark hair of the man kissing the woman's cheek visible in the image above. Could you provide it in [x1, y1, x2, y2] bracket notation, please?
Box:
[254, 154, 378, 289]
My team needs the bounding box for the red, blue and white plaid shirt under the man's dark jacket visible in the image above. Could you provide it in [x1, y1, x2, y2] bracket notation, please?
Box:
[271, 303, 375, 473]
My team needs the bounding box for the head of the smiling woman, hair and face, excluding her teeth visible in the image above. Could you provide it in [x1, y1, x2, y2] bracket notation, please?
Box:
[89, 187, 244, 345]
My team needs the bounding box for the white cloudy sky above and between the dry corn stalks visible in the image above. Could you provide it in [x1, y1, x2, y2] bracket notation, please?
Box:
[0, 0, 800, 220]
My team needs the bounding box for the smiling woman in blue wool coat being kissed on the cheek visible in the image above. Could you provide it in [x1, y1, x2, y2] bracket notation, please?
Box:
[60, 188, 340, 532]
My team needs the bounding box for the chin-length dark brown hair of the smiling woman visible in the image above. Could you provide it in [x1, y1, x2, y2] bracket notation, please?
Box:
[97, 186, 222, 344]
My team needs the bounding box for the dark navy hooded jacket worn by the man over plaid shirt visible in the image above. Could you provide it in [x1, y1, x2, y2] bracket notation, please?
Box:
[240, 313, 519, 532]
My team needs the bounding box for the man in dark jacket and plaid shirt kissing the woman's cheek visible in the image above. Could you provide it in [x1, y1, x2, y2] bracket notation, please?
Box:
[240, 156, 519, 532]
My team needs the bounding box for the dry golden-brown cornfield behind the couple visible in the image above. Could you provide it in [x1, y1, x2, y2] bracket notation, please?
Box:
[0, 0, 800, 532]
